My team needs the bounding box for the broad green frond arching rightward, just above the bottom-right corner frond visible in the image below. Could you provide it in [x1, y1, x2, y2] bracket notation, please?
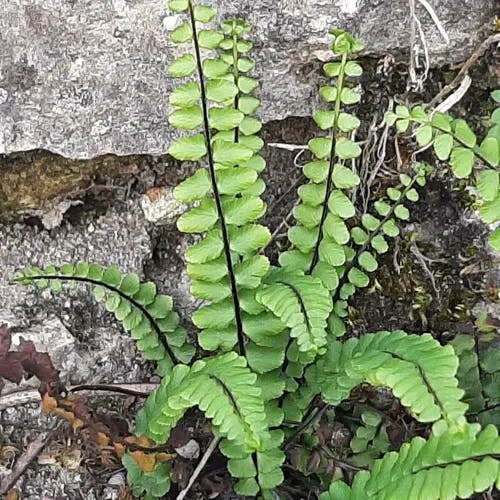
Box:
[300, 331, 467, 426]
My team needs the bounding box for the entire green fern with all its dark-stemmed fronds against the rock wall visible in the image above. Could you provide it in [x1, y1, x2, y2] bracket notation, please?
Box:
[12, 0, 500, 500]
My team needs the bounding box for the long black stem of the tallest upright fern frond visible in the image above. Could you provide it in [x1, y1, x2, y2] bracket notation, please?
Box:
[189, 0, 246, 356]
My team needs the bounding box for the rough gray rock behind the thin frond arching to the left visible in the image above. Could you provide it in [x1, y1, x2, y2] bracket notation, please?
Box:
[0, 202, 151, 384]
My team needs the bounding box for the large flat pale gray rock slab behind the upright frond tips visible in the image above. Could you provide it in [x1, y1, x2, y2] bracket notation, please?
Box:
[0, 0, 495, 158]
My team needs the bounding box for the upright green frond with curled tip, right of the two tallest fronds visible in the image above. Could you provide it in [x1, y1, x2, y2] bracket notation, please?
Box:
[280, 30, 362, 291]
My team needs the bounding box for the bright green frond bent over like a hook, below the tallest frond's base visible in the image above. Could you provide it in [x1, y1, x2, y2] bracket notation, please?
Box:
[137, 352, 267, 453]
